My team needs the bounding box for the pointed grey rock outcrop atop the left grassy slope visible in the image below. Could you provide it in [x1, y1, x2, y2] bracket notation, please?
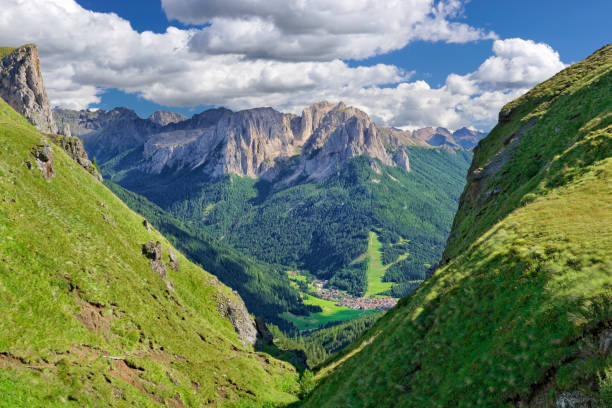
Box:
[0, 44, 57, 133]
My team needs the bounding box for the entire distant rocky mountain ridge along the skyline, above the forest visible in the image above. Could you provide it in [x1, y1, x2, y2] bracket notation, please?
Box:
[53, 102, 485, 183]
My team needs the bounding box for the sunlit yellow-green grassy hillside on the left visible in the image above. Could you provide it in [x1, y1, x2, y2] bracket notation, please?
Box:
[0, 100, 297, 407]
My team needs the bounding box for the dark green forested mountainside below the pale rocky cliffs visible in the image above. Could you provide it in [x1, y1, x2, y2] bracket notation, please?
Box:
[111, 147, 471, 295]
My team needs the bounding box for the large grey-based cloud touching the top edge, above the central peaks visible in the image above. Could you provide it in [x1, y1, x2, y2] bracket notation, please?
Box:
[162, 0, 496, 61]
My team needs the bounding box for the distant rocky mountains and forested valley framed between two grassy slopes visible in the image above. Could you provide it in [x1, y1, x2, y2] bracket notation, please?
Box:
[54, 97, 470, 331]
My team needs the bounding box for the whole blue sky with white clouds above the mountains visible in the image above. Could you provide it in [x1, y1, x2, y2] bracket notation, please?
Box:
[0, 0, 612, 131]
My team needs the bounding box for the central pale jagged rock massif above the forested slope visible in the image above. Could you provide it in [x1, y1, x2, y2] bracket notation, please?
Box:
[141, 102, 402, 182]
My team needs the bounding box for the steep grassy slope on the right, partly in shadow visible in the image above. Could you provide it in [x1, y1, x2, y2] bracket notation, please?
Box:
[305, 47, 612, 407]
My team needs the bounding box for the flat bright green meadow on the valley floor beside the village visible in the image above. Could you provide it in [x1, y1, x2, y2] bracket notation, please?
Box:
[282, 294, 377, 331]
